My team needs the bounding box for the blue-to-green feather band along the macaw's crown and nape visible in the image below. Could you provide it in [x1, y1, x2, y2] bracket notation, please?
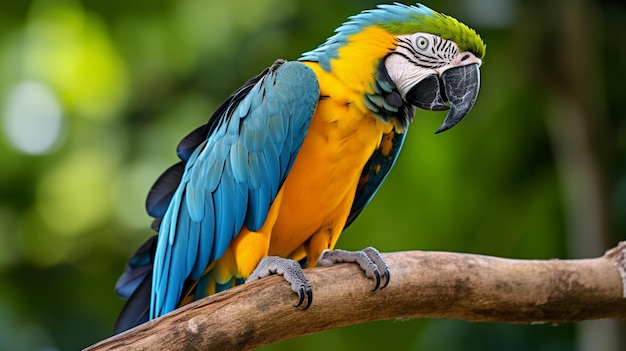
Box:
[300, 3, 486, 71]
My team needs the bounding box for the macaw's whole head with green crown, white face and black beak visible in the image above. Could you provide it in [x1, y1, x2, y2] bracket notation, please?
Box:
[300, 3, 486, 133]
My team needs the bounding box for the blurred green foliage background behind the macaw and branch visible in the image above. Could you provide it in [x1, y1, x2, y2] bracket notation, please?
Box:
[0, 0, 626, 350]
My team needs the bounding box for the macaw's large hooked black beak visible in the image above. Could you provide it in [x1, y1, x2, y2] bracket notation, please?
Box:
[406, 64, 480, 133]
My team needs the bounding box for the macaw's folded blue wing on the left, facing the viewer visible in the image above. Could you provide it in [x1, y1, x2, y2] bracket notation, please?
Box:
[147, 61, 319, 318]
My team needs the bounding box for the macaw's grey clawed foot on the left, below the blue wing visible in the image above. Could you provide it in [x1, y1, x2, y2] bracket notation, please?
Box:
[246, 256, 313, 310]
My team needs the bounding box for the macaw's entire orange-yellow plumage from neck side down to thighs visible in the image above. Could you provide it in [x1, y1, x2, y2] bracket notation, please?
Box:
[224, 27, 395, 280]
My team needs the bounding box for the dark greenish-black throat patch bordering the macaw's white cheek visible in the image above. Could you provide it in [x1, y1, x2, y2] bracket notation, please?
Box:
[365, 57, 415, 131]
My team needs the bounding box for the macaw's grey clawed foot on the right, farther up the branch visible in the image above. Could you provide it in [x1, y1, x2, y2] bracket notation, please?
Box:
[317, 247, 389, 291]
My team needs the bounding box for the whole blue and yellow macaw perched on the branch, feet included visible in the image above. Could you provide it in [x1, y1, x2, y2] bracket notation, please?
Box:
[115, 3, 485, 332]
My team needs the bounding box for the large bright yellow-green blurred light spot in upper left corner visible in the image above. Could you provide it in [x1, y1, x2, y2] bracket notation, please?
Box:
[23, 1, 127, 119]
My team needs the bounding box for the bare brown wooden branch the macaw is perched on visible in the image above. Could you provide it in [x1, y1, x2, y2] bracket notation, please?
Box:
[86, 242, 626, 351]
